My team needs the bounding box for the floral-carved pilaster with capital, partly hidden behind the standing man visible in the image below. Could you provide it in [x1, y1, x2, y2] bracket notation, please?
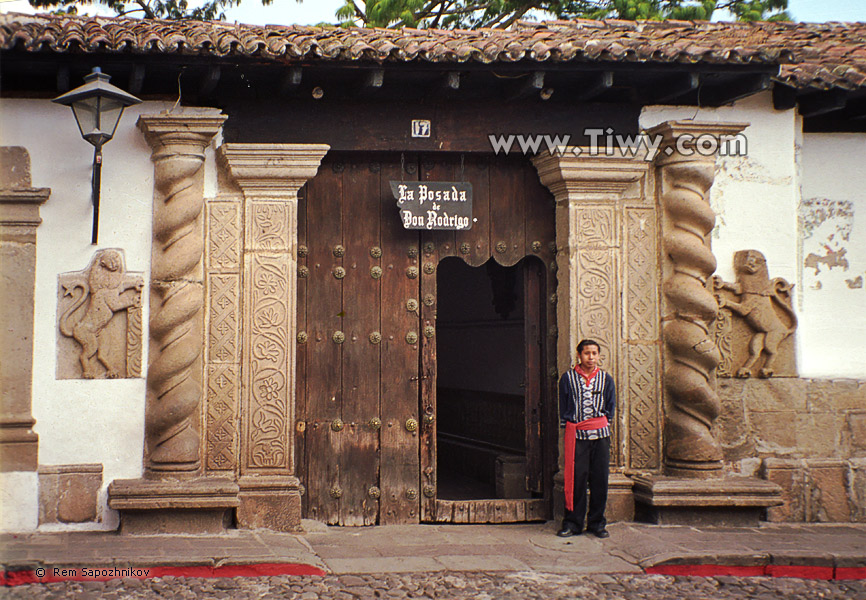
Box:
[533, 148, 652, 478]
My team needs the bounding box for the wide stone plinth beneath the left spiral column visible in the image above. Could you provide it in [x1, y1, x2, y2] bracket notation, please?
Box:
[108, 478, 239, 534]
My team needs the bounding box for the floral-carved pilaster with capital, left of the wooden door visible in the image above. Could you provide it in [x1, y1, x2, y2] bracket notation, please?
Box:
[220, 144, 329, 476]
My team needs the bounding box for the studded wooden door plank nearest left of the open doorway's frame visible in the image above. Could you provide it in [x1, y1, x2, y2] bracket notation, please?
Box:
[379, 156, 422, 525]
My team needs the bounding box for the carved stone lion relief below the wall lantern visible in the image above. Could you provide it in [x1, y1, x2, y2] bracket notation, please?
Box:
[57, 249, 144, 379]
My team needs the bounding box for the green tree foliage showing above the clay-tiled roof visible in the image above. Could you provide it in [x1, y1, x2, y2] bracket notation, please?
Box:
[30, 0, 790, 29]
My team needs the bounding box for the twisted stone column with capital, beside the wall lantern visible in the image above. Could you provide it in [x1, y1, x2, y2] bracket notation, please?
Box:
[139, 114, 226, 477]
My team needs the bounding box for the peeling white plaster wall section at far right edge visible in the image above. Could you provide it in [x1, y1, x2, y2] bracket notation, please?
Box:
[798, 133, 866, 378]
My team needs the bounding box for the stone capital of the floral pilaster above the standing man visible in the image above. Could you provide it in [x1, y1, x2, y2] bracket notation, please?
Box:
[532, 146, 649, 204]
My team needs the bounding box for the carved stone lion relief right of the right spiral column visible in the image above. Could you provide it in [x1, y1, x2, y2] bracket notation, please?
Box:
[710, 250, 797, 378]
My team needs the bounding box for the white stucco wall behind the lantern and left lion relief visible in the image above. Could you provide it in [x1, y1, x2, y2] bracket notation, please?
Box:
[0, 99, 223, 531]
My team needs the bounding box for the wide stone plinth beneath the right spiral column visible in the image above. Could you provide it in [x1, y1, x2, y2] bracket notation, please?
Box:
[634, 476, 782, 527]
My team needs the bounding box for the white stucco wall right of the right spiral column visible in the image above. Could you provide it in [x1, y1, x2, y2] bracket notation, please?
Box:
[640, 93, 866, 378]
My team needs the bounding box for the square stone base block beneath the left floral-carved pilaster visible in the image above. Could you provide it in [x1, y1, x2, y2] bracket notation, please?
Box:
[237, 476, 301, 531]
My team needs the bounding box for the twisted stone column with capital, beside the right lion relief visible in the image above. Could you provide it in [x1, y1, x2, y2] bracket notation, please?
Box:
[649, 122, 745, 478]
